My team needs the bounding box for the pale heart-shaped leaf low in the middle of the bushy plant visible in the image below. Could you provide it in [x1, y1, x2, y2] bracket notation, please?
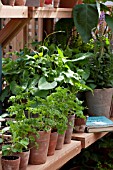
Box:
[38, 77, 57, 90]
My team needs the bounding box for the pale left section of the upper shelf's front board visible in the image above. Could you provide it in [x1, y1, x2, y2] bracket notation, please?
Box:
[0, 5, 28, 18]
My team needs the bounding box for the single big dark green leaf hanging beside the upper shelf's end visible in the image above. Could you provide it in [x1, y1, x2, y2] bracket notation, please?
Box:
[73, 4, 99, 43]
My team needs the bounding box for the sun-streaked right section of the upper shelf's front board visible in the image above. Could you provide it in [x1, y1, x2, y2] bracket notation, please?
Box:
[29, 7, 72, 18]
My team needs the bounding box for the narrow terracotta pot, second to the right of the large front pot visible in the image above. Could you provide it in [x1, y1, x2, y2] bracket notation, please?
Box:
[55, 132, 66, 150]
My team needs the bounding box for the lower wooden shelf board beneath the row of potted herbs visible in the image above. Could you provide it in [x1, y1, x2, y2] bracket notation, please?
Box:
[27, 141, 81, 170]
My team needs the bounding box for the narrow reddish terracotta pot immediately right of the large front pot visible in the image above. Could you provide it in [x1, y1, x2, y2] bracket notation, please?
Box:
[47, 132, 58, 156]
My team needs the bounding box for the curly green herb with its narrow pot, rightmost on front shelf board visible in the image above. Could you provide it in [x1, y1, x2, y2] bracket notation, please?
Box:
[48, 87, 76, 147]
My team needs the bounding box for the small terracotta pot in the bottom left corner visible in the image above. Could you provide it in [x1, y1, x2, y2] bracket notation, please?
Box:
[1, 156, 20, 170]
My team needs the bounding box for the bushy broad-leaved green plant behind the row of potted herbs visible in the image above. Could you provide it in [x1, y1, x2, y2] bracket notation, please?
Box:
[0, 41, 87, 106]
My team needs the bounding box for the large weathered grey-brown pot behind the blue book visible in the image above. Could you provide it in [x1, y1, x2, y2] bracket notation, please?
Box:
[85, 88, 113, 118]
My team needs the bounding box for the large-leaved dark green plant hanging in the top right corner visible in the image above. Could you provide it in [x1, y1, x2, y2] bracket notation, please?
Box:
[73, 0, 113, 43]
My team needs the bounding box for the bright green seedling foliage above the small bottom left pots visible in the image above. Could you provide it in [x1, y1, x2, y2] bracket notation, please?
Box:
[2, 121, 29, 156]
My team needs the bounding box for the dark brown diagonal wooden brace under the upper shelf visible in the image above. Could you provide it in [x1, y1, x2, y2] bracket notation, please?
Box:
[0, 18, 30, 47]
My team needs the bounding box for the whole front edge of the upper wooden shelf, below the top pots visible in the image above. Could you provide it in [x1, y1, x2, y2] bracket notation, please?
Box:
[0, 5, 72, 18]
